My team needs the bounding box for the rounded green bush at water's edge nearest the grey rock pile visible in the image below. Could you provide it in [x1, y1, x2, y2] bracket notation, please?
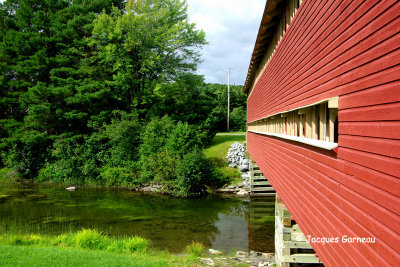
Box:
[176, 149, 215, 197]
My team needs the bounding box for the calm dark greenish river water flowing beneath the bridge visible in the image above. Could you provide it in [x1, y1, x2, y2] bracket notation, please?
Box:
[0, 185, 274, 252]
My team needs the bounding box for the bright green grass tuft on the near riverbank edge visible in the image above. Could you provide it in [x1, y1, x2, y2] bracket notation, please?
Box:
[75, 229, 110, 250]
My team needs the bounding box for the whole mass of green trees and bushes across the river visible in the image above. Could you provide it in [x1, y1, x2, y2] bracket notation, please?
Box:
[0, 0, 246, 197]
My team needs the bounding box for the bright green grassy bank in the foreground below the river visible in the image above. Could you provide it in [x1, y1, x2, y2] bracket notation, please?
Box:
[0, 230, 198, 266]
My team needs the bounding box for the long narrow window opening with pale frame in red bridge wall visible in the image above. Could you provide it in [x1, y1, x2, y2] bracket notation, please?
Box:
[248, 97, 339, 150]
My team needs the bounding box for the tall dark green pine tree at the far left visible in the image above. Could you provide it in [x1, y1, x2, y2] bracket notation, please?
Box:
[0, 0, 123, 176]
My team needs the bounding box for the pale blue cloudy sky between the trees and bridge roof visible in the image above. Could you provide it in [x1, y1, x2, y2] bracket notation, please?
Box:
[187, 0, 266, 85]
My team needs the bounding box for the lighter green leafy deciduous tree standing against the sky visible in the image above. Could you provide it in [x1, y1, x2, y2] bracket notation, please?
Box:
[90, 0, 206, 114]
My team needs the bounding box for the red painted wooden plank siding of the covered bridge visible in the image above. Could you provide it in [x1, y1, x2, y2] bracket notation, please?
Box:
[247, 0, 400, 266]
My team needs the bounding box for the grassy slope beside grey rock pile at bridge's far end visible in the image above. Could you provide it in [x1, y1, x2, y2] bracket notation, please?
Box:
[204, 132, 246, 184]
